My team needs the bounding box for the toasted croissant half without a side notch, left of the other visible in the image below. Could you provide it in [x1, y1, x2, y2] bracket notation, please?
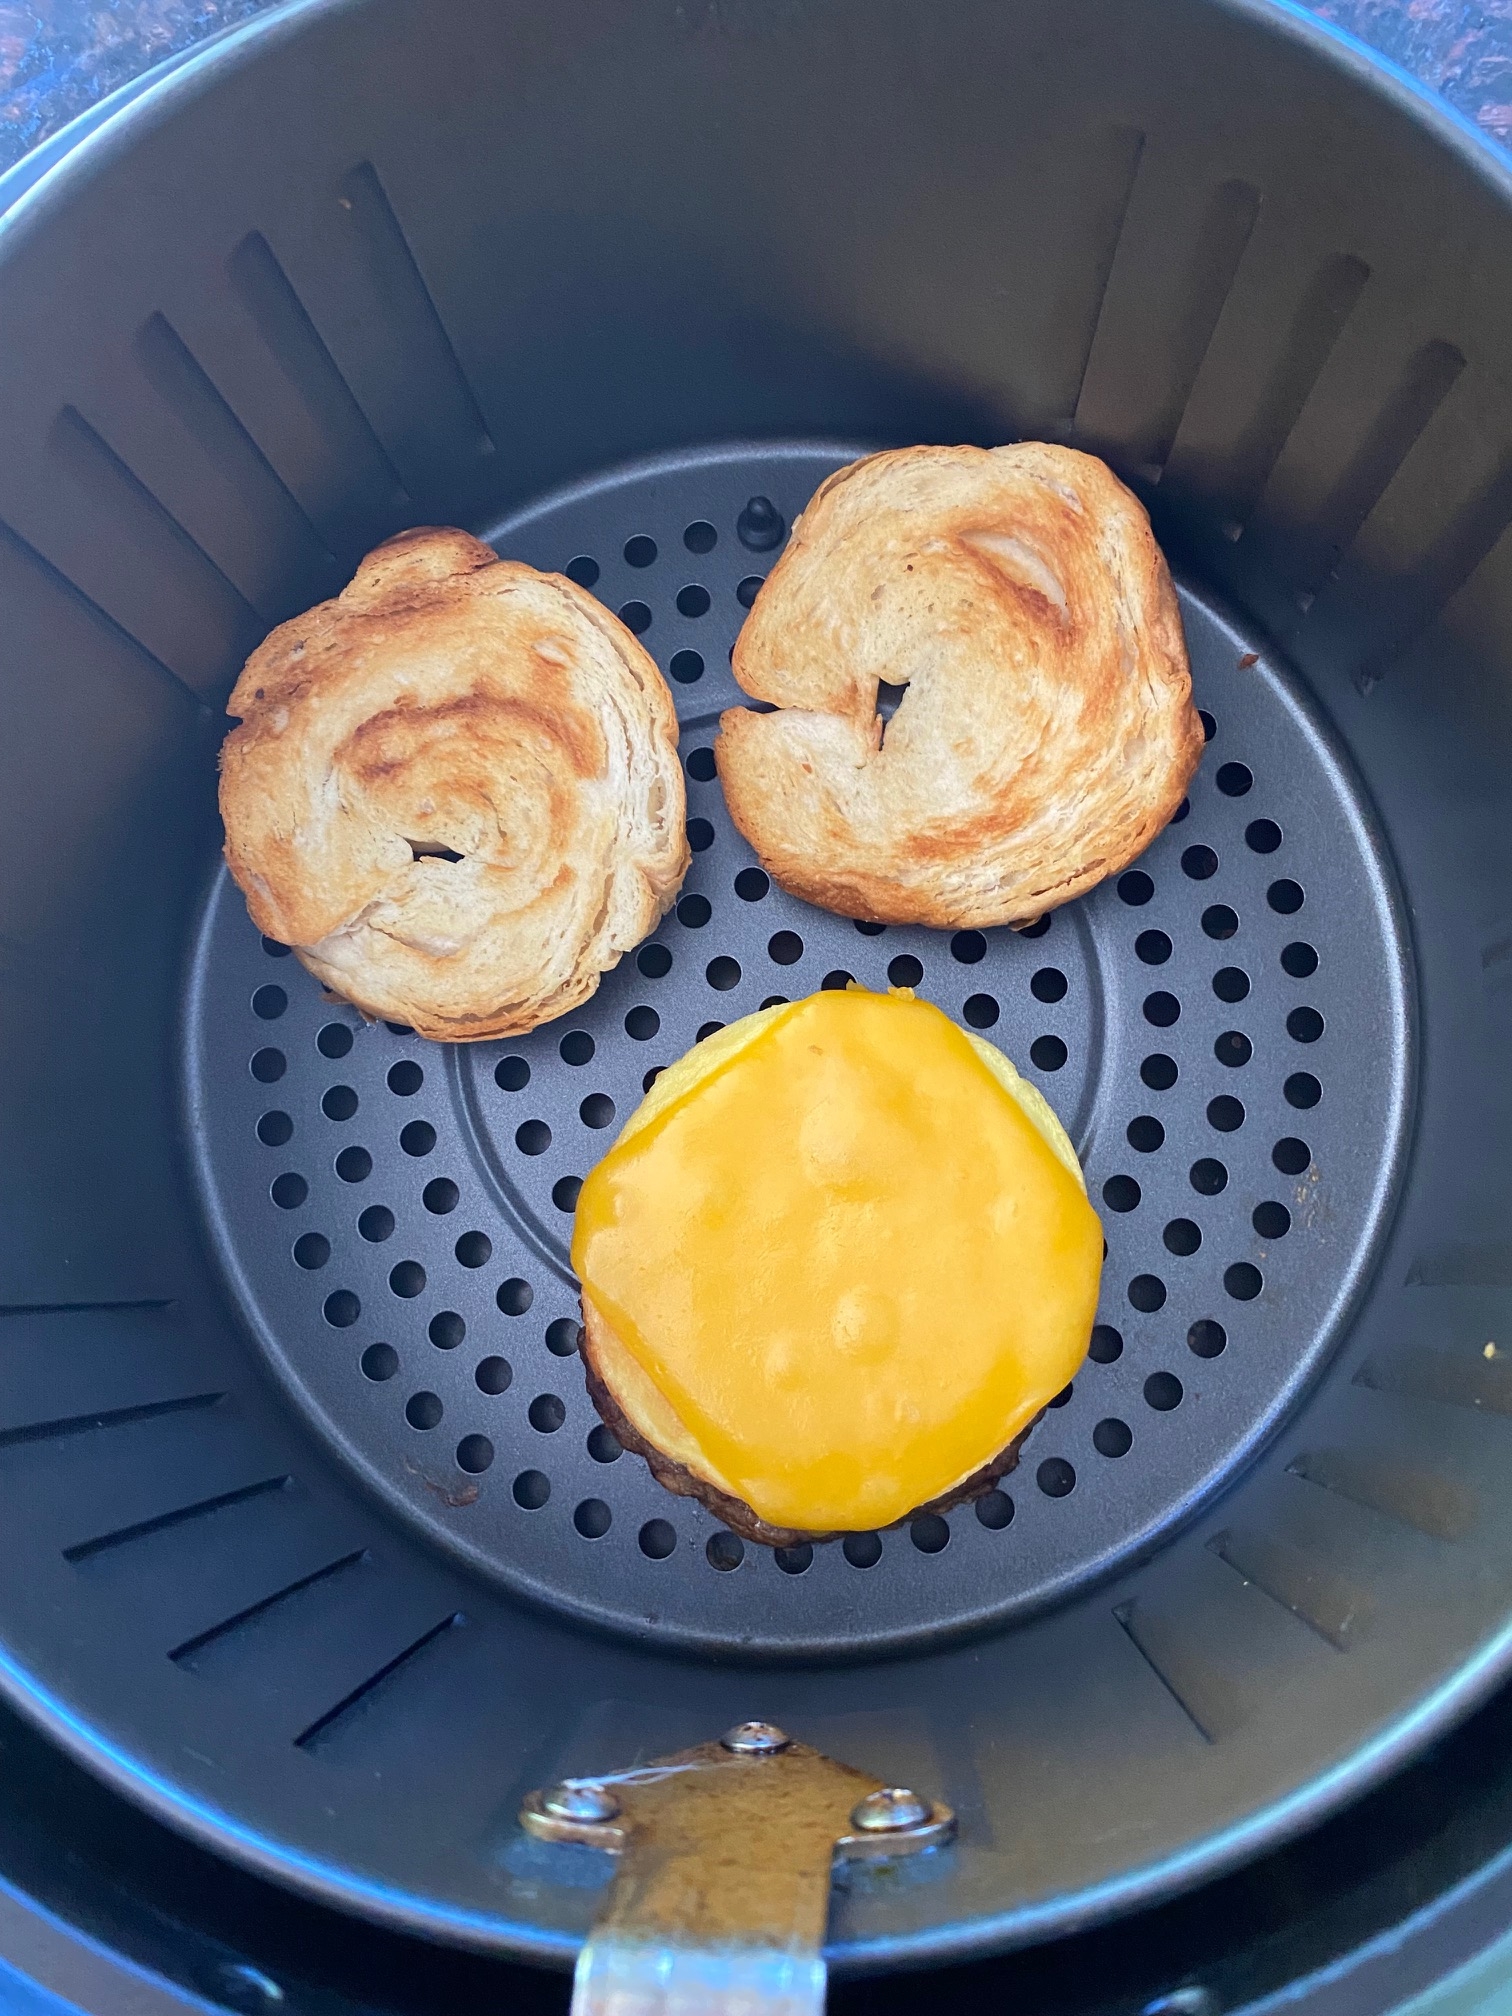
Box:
[220, 528, 689, 1042]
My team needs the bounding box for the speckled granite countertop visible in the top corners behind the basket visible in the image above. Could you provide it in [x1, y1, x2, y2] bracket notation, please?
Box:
[0, 0, 1512, 169]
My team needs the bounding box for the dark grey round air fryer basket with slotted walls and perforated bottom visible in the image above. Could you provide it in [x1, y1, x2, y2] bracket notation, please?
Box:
[0, 0, 1512, 1964]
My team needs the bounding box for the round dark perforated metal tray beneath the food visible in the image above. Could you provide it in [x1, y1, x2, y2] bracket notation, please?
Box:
[185, 444, 1409, 1657]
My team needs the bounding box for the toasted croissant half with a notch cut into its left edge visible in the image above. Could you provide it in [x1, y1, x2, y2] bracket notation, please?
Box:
[716, 444, 1204, 927]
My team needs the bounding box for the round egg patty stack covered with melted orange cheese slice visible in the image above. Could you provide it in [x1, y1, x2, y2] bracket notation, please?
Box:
[573, 988, 1103, 1532]
